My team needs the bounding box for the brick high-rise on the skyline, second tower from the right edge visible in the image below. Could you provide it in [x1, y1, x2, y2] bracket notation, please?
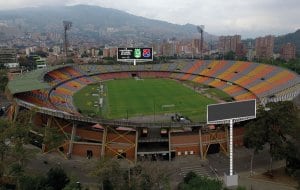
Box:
[255, 35, 274, 59]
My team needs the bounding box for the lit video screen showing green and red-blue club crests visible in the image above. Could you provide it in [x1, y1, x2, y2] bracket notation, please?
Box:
[118, 47, 153, 61]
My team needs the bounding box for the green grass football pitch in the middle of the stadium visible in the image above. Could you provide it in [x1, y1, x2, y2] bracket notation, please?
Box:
[73, 79, 216, 122]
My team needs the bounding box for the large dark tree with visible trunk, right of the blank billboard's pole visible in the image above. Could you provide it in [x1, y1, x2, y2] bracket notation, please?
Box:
[244, 101, 297, 172]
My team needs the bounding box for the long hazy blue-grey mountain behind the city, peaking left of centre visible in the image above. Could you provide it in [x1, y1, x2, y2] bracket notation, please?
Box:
[0, 5, 217, 41]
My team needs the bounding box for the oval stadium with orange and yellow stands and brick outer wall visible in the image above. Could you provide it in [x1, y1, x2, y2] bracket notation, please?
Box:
[7, 60, 300, 161]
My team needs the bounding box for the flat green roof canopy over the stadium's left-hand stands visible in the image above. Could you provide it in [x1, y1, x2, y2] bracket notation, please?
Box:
[7, 65, 69, 94]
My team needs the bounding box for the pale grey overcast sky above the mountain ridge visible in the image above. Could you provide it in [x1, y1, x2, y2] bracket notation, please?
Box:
[0, 0, 300, 38]
